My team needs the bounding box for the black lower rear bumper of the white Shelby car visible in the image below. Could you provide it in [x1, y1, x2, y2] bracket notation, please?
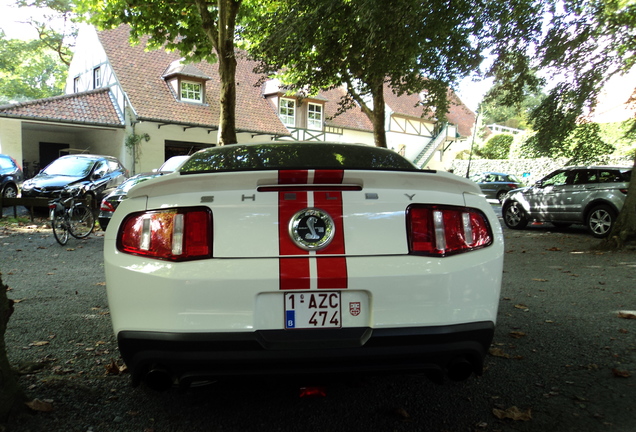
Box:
[118, 322, 494, 385]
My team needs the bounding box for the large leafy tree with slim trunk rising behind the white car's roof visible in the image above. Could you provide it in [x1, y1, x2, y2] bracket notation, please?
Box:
[243, 0, 544, 146]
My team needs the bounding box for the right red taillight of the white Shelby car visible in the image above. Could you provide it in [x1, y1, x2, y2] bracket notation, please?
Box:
[406, 205, 493, 256]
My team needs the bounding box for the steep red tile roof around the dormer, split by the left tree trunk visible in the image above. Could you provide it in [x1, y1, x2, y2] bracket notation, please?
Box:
[98, 25, 289, 135]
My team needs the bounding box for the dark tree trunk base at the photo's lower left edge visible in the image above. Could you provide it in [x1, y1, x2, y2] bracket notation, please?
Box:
[0, 278, 26, 424]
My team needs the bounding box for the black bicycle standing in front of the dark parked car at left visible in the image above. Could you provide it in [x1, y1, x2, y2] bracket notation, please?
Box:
[49, 187, 95, 245]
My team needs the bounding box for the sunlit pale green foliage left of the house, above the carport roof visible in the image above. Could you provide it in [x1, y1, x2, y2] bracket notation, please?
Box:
[0, 31, 67, 104]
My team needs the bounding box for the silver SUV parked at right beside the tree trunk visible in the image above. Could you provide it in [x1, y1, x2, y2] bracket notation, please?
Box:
[502, 166, 632, 238]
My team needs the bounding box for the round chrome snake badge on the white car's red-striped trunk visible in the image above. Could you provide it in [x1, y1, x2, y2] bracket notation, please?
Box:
[289, 208, 335, 250]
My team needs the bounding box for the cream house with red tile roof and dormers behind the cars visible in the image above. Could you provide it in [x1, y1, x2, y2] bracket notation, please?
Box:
[0, 25, 475, 174]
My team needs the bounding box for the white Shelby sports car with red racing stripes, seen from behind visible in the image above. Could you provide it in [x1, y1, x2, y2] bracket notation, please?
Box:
[104, 141, 503, 389]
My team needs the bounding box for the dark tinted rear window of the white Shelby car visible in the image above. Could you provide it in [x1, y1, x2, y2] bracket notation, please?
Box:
[179, 142, 419, 174]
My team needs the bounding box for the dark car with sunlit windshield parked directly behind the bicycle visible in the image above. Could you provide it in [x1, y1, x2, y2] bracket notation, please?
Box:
[22, 154, 128, 206]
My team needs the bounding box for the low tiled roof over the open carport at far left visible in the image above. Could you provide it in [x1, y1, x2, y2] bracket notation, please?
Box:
[0, 88, 124, 127]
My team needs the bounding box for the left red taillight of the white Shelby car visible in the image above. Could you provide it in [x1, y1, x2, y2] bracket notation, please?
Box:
[117, 207, 212, 261]
